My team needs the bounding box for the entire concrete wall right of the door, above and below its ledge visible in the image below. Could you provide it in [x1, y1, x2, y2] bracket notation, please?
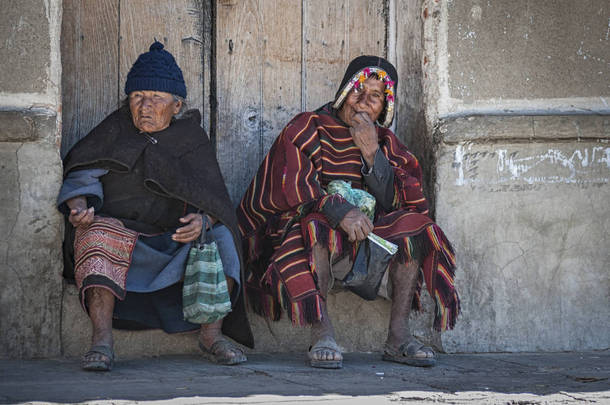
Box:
[423, 0, 610, 352]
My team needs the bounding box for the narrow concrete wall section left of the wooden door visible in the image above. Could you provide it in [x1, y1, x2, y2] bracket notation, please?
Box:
[0, 0, 62, 357]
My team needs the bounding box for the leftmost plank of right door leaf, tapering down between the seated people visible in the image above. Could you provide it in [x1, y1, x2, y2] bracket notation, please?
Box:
[216, 0, 264, 204]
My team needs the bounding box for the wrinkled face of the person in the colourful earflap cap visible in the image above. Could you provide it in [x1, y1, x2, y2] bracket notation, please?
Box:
[339, 75, 385, 127]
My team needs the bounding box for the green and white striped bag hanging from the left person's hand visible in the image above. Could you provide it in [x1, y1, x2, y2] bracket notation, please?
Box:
[182, 215, 231, 324]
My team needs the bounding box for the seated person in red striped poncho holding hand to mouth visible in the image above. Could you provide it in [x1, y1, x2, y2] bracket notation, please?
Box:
[237, 56, 459, 368]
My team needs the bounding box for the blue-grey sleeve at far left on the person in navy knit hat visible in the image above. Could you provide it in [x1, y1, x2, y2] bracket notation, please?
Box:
[57, 169, 108, 215]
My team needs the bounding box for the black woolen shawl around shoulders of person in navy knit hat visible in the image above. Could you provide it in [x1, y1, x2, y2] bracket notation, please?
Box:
[63, 106, 254, 347]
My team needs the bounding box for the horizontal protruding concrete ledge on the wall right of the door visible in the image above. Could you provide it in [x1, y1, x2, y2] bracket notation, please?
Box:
[438, 115, 610, 144]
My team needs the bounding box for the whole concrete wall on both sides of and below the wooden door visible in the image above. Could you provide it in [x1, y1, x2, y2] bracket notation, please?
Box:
[0, 0, 610, 357]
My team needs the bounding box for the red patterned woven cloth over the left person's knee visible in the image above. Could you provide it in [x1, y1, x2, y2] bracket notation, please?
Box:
[74, 217, 138, 310]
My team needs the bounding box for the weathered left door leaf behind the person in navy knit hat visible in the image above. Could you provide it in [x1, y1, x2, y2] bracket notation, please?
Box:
[61, 0, 211, 155]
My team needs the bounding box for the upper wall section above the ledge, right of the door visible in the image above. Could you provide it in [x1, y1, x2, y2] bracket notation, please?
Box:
[424, 0, 610, 120]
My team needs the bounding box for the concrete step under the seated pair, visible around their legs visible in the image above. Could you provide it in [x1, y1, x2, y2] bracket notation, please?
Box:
[61, 282, 440, 358]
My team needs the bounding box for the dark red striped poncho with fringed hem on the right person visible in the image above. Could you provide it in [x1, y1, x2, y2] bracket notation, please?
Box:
[237, 107, 460, 330]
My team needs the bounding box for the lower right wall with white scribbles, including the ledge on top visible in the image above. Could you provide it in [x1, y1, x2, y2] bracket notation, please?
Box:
[437, 115, 610, 351]
